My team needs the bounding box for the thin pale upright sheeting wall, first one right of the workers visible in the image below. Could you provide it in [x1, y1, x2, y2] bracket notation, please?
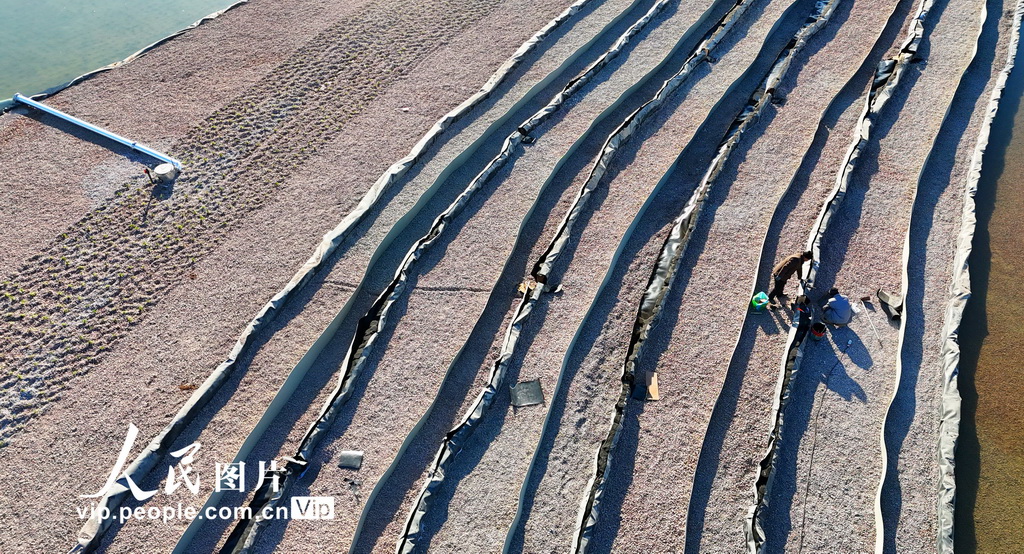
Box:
[874, 0, 988, 554]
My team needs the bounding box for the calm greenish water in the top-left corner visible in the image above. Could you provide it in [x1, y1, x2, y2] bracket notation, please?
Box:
[0, 0, 234, 102]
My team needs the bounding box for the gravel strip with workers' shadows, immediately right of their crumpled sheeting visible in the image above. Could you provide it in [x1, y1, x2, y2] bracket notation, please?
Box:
[766, 0, 984, 551]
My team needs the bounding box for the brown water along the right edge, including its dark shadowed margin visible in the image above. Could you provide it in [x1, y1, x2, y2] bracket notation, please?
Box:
[954, 29, 1024, 554]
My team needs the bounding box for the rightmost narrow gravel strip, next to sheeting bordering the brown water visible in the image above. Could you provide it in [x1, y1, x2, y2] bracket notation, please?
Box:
[882, 1, 1013, 552]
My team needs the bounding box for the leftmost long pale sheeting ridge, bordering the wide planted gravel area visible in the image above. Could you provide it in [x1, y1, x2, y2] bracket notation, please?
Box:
[72, 0, 595, 551]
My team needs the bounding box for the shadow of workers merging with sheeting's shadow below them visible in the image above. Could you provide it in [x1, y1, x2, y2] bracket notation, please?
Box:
[764, 327, 872, 552]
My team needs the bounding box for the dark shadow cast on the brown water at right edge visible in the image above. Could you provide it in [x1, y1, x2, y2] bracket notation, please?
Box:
[953, 6, 1024, 553]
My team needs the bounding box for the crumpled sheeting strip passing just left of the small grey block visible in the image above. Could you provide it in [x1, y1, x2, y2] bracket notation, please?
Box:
[223, 0, 670, 553]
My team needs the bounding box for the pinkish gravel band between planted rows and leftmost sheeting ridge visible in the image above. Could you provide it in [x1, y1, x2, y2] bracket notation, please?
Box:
[0, 0, 581, 551]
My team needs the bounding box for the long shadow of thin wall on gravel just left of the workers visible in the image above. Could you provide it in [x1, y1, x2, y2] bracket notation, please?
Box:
[685, 0, 911, 553]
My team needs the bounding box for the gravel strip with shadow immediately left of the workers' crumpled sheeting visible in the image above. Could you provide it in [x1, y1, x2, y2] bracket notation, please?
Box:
[684, 1, 913, 552]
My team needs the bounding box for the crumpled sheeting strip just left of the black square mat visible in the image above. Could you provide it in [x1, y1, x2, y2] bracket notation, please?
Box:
[396, 0, 770, 553]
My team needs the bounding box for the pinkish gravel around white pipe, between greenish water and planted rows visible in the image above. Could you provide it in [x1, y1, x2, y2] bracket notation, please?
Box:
[0, 0, 371, 272]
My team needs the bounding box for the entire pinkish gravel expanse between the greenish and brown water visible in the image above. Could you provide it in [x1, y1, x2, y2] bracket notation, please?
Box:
[0, 0, 1013, 553]
